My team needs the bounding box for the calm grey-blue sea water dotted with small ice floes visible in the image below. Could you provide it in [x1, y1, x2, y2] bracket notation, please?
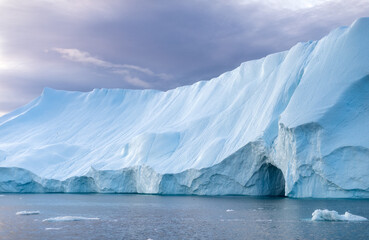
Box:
[0, 194, 369, 240]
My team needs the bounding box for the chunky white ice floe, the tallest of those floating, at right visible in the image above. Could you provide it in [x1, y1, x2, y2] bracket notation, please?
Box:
[311, 209, 368, 221]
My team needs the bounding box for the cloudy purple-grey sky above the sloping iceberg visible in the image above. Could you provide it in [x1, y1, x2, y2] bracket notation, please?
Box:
[0, 0, 369, 116]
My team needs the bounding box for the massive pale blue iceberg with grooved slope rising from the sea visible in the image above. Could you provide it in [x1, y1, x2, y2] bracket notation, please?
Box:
[0, 18, 369, 197]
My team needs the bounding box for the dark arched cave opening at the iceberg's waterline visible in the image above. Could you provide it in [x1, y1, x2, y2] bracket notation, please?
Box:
[256, 163, 285, 196]
